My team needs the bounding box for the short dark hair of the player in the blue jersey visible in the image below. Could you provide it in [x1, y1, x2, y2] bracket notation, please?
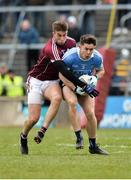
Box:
[80, 34, 96, 46]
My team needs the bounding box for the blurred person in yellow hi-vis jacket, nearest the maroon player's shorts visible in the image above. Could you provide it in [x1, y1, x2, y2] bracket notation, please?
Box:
[5, 70, 25, 97]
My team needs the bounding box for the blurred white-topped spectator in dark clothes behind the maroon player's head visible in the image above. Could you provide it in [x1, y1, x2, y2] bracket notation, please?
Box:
[67, 16, 81, 42]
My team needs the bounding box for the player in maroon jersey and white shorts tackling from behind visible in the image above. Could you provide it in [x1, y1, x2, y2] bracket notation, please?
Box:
[20, 21, 84, 154]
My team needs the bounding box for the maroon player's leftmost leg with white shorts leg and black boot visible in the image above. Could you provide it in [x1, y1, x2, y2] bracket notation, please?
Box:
[20, 78, 42, 154]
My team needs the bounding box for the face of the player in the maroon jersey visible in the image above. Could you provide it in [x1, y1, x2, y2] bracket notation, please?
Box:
[53, 31, 67, 45]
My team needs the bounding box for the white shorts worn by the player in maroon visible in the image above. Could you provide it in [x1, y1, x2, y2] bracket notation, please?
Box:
[26, 77, 59, 104]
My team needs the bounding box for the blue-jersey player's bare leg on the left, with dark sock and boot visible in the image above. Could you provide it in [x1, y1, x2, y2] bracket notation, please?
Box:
[63, 86, 83, 149]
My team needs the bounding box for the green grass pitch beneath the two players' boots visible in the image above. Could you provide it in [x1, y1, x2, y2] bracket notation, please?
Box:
[0, 127, 131, 179]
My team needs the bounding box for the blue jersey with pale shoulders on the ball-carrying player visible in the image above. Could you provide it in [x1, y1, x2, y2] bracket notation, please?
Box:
[63, 47, 103, 77]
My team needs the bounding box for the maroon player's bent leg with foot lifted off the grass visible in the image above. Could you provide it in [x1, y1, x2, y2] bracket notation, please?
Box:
[34, 83, 62, 144]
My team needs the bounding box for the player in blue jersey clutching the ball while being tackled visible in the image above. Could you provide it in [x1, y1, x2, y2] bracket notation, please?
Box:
[60, 34, 108, 155]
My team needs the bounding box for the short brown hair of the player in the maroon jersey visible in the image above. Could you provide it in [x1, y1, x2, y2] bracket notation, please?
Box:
[52, 21, 68, 32]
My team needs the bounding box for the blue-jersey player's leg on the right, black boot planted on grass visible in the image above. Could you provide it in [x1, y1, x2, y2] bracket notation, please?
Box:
[79, 96, 108, 155]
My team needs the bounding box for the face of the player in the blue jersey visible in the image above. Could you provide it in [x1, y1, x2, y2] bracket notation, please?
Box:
[80, 44, 96, 60]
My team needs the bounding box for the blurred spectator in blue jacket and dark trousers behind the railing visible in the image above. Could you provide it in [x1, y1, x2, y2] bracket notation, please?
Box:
[18, 20, 39, 71]
